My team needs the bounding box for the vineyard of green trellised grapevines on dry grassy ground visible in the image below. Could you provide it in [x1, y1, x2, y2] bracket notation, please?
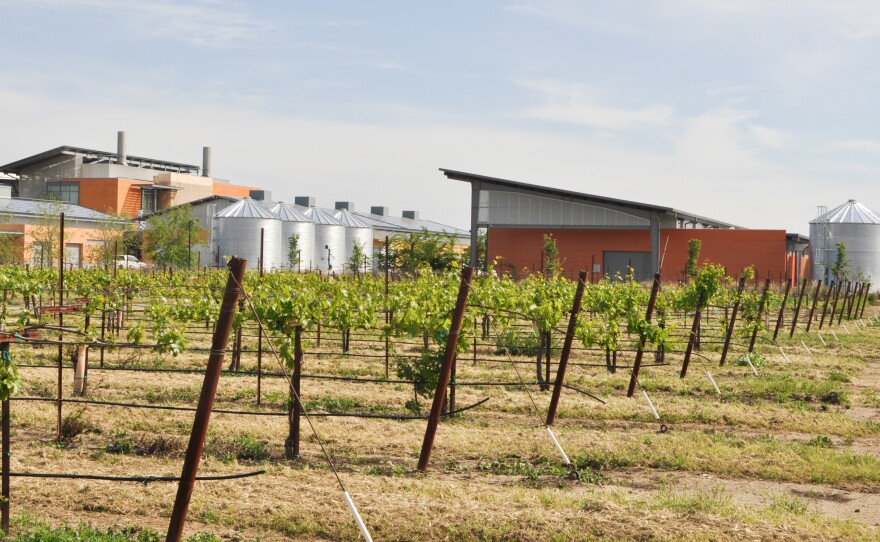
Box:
[0, 264, 880, 541]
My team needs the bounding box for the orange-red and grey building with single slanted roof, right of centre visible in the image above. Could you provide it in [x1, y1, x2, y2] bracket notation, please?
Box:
[441, 169, 809, 281]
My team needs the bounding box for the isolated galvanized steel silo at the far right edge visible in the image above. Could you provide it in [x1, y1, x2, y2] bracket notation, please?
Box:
[810, 199, 880, 289]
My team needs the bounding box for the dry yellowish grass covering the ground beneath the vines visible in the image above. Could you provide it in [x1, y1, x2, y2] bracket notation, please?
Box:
[5, 306, 880, 541]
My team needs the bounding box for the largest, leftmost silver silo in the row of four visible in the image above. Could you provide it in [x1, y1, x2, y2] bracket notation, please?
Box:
[214, 198, 281, 270]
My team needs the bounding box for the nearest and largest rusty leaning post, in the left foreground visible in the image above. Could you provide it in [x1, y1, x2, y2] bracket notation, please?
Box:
[165, 256, 247, 542]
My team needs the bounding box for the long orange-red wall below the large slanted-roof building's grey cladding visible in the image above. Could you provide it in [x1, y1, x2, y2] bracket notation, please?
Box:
[488, 228, 787, 281]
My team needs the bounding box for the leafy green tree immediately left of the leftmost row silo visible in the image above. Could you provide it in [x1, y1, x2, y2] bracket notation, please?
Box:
[144, 204, 207, 267]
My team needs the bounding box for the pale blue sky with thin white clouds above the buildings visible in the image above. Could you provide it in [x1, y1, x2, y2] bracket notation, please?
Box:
[0, 0, 880, 234]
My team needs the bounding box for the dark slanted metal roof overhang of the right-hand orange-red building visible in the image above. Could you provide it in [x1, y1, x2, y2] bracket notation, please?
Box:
[440, 168, 743, 229]
